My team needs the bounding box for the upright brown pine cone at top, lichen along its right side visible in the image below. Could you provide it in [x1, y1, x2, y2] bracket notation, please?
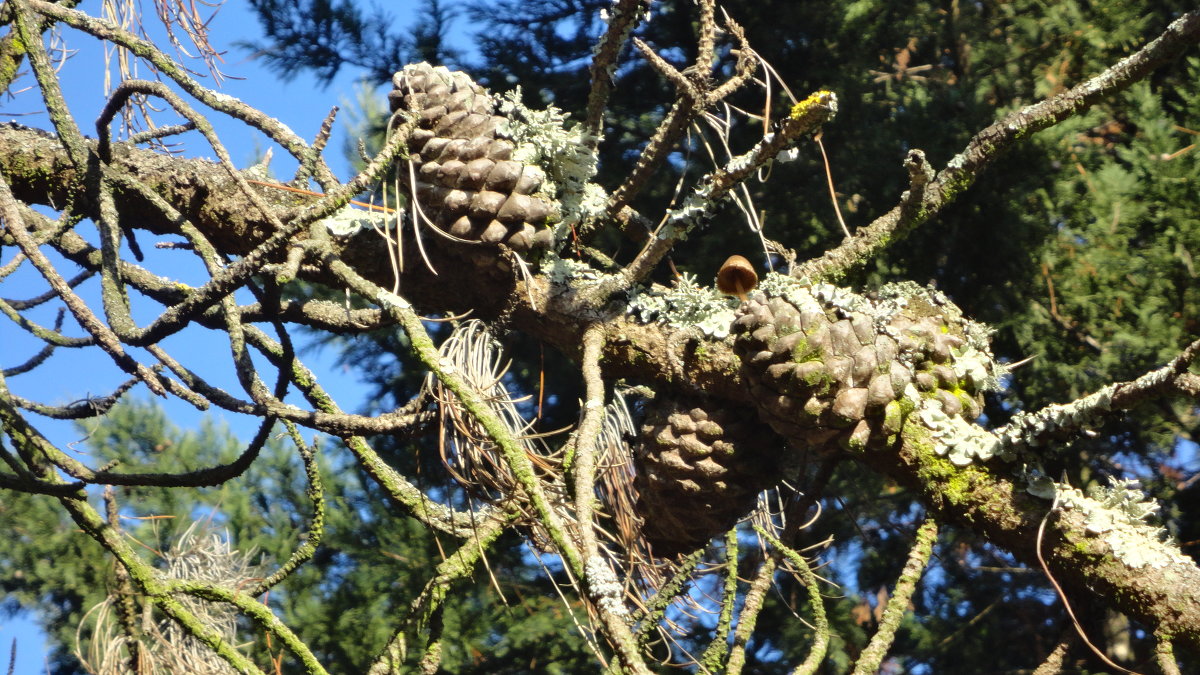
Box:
[388, 62, 558, 251]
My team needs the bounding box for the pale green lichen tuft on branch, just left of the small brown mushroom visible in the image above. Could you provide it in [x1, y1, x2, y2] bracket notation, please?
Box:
[629, 273, 738, 340]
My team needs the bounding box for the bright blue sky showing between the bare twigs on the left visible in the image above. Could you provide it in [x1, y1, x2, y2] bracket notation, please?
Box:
[0, 0, 462, 674]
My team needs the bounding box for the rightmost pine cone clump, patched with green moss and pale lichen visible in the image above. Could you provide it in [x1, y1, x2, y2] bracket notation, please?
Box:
[733, 285, 995, 452]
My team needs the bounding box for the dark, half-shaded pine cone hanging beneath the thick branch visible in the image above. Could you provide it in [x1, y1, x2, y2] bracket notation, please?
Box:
[634, 399, 784, 556]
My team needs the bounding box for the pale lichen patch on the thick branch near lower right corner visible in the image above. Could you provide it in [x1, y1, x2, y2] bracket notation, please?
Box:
[1026, 477, 1189, 568]
